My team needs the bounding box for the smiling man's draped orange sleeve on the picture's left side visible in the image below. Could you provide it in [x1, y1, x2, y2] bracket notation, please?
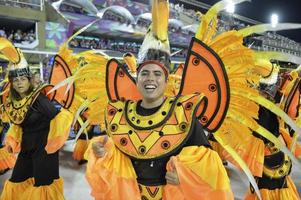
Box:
[85, 136, 141, 200]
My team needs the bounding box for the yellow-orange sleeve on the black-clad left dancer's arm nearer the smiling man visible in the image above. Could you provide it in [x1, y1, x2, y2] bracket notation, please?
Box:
[45, 108, 73, 154]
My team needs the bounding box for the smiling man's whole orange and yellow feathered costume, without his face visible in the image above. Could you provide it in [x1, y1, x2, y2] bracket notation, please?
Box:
[42, 0, 300, 200]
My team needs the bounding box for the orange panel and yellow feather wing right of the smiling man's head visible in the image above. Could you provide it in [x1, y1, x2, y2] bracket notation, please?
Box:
[176, 0, 300, 197]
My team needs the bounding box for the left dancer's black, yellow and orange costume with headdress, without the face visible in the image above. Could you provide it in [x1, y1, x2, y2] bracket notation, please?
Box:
[0, 38, 74, 200]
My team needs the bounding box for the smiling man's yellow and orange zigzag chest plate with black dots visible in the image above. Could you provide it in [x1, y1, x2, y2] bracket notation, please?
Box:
[106, 94, 206, 159]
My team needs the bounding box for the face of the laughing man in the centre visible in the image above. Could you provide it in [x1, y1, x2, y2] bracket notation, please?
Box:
[137, 63, 167, 102]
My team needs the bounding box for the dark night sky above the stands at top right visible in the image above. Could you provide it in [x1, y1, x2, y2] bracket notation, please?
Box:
[176, 0, 301, 43]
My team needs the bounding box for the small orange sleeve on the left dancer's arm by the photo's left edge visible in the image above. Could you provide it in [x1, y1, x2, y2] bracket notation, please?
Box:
[5, 124, 22, 153]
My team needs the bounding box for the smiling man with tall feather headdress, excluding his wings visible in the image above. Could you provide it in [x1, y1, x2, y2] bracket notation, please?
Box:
[87, 0, 233, 200]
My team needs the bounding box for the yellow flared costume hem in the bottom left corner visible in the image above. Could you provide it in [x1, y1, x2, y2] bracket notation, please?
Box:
[0, 178, 34, 200]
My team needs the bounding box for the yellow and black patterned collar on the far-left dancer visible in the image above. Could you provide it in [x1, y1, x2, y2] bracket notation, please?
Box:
[2, 84, 52, 125]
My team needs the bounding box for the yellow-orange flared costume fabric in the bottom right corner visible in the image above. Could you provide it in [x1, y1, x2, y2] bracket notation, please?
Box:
[245, 176, 300, 200]
